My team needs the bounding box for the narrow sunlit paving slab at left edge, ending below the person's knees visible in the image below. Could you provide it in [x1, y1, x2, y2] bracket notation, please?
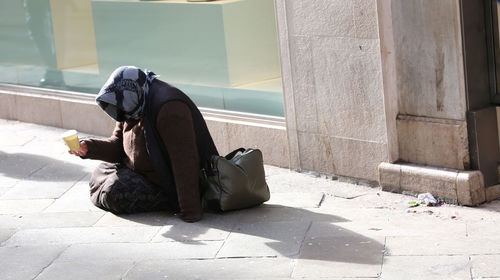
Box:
[0, 212, 104, 229]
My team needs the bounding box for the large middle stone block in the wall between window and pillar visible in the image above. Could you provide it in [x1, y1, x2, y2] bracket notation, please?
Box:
[312, 37, 386, 142]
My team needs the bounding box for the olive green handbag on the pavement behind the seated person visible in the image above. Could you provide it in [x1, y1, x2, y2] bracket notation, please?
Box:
[200, 148, 270, 211]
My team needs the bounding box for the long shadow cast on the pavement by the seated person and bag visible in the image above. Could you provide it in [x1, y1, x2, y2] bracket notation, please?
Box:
[115, 204, 384, 265]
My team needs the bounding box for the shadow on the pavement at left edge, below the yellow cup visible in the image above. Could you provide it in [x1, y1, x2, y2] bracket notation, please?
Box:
[0, 151, 84, 182]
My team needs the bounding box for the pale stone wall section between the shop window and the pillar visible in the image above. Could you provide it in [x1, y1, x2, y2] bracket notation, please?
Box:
[275, 0, 389, 181]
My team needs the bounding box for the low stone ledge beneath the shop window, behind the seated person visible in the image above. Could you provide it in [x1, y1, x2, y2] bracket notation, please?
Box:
[0, 85, 290, 168]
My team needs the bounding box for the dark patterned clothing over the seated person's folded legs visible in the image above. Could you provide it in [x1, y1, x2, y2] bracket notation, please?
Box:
[89, 163, 170, 214]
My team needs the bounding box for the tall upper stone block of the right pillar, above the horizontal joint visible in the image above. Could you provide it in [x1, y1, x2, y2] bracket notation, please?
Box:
[392, 0, 466, 120]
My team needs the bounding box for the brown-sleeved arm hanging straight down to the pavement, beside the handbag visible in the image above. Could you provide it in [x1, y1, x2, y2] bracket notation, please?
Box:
[156, 101, 202, 222]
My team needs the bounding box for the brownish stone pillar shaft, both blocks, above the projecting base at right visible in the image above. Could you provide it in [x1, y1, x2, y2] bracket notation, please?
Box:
[391, 0, 470, 169]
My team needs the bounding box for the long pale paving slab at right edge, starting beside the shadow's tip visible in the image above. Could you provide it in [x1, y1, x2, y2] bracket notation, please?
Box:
[386, 235, 500, 256]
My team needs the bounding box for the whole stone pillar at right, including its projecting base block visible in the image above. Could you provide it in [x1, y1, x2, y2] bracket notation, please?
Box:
[379, 0, 485, 205]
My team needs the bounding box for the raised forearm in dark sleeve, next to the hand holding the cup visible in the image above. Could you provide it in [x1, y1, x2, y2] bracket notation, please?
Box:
[81, 122, 124, 163]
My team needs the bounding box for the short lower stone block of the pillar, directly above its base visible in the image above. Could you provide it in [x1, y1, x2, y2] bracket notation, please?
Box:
[397, 115, 469, 169]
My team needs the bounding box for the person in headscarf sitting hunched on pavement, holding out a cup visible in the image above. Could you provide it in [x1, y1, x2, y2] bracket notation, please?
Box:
[70, 66, 218, 222]
